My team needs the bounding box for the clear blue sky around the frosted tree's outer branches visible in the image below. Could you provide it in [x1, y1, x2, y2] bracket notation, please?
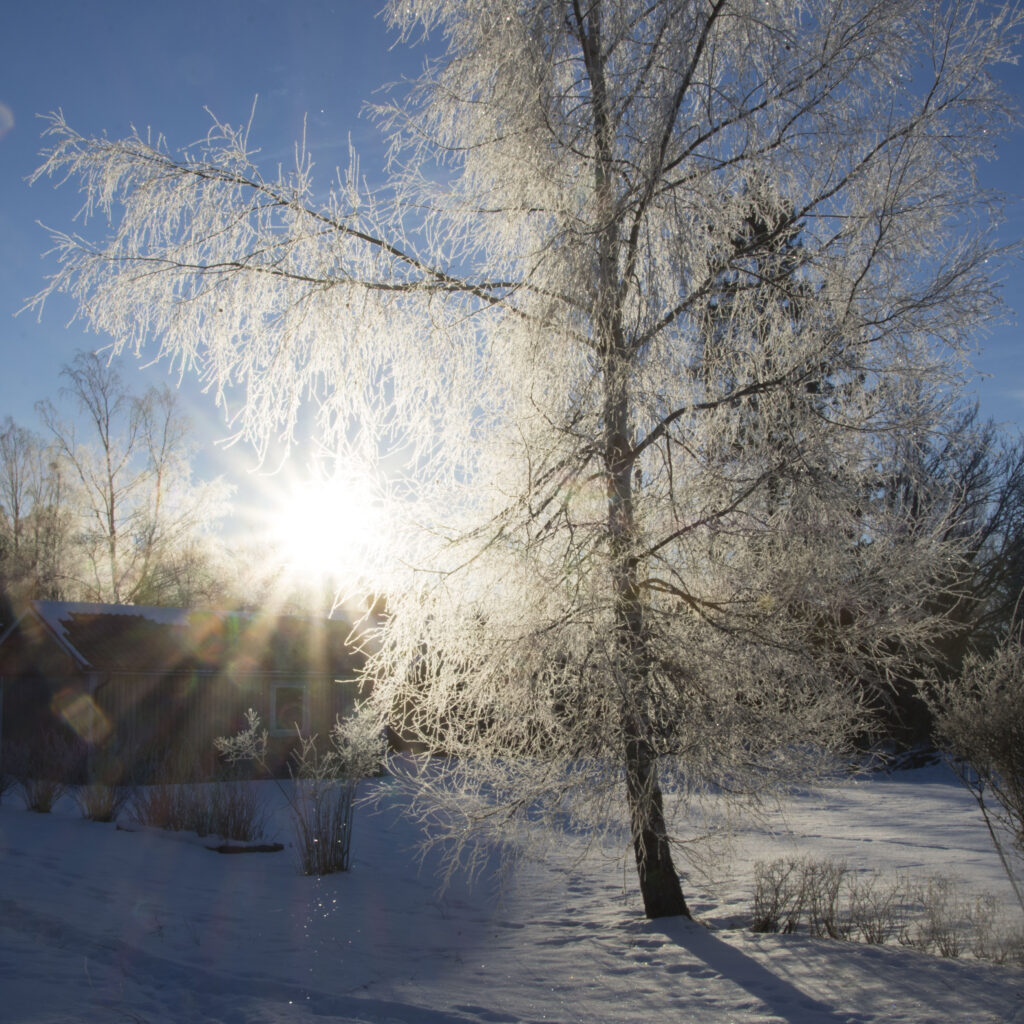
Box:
[0, 0, 1024, 499]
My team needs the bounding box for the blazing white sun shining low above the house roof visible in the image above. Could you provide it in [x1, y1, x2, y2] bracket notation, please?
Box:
[268, 473, 389, 584]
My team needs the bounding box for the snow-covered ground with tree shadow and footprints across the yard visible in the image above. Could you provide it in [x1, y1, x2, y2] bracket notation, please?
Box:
[0, 769, 1024, 1024]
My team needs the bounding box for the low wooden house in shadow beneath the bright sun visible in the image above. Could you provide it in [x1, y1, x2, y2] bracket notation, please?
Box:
[0, 601, 362, 774]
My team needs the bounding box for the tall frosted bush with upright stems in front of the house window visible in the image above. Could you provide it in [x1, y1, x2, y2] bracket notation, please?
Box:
[216, 709, 383, 874]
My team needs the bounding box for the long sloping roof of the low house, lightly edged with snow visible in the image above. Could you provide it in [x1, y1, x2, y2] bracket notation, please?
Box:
[0, 601, 361, 675]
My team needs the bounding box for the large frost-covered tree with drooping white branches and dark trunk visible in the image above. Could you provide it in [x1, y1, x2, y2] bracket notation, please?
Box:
[28, 0, 1020, 916]
